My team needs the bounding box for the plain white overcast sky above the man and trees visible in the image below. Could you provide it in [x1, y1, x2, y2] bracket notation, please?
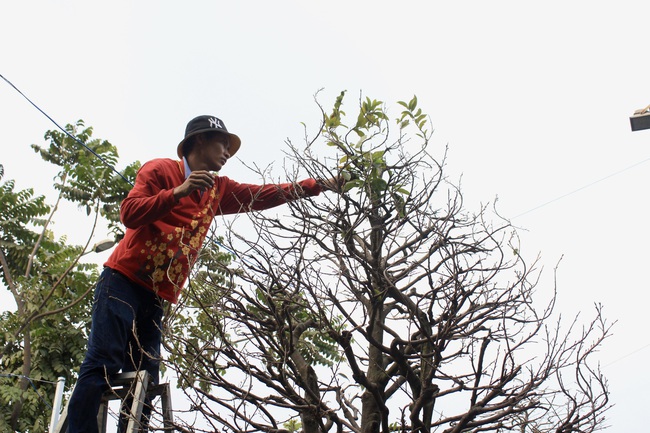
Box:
[0, 0, 650, 431]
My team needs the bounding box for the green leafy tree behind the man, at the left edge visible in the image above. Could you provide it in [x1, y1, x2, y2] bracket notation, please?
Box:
[0, 120, 139, 433]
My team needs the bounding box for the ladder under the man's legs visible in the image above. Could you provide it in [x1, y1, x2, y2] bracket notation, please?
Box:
[53, 370, 174, 433]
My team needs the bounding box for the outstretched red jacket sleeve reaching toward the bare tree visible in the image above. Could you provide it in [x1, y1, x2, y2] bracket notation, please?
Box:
[219, 176, 322, 214]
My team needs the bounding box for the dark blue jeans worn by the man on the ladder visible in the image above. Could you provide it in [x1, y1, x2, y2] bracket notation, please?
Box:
[68, 268, 163, 433]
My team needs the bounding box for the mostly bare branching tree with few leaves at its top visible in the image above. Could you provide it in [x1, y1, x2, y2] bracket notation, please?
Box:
[161, 93, 610, 433]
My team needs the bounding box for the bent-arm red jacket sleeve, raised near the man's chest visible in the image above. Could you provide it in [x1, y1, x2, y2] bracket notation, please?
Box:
[120, 162, 176, 229]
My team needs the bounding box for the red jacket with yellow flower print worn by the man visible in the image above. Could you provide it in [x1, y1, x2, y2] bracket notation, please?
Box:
[105, 158, 321, 303]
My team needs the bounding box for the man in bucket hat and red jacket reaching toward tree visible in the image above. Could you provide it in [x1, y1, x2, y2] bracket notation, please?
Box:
[68, 116, 339, 433]
